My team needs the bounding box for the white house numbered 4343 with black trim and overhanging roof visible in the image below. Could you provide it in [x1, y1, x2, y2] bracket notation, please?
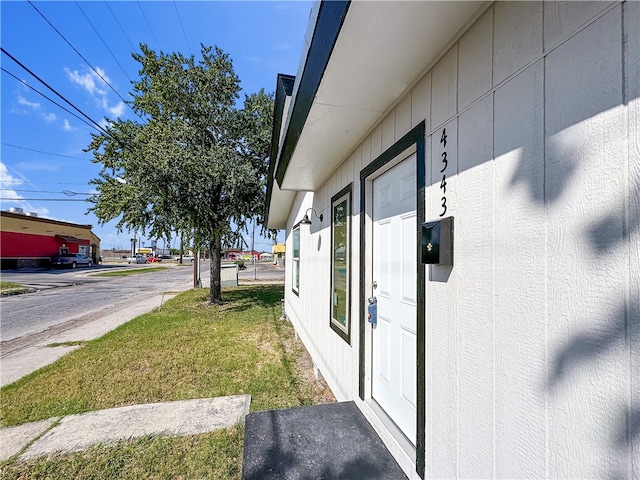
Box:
[268, 1, 640, 479]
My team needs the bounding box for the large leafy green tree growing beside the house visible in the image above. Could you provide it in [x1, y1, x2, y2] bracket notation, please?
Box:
[88, 45, 273, 303]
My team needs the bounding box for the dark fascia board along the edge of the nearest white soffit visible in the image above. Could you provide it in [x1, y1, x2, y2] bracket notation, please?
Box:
[275, 0, 351, 185]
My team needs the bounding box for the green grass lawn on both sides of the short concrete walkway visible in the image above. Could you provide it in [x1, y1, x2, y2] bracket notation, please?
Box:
[0, 285, 328, 479]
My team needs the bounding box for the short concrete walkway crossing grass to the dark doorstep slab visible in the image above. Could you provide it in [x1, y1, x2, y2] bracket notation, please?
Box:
[0, 395, 251, 461]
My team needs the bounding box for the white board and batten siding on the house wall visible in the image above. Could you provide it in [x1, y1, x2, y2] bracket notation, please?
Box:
[286, 2, 640, 479]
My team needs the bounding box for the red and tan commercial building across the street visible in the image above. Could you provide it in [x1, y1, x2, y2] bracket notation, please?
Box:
[0, 208, 100, 270]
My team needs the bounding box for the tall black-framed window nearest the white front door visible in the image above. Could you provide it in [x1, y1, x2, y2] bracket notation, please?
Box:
[331, 185, 351, 343]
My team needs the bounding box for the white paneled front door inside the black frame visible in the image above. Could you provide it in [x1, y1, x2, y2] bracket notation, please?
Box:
[371, 154, 417, 445]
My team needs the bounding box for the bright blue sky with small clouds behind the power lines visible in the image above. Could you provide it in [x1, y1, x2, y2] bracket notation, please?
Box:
[0, 0, 311, 250]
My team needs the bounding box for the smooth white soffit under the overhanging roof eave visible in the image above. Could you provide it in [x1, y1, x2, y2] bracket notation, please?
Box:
[276, 1, 484, 191]
